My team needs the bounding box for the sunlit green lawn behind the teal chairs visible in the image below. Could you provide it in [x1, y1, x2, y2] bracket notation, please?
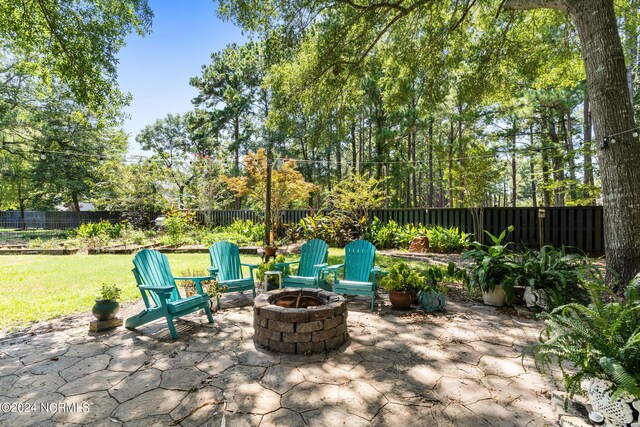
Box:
[0, 249, 410, 331]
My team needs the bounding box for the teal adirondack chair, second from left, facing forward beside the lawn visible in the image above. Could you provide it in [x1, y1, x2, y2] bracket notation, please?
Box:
[207, 241, 258, 310]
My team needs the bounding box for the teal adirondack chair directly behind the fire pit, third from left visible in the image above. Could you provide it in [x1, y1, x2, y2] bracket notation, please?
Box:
[275, 239, 329, 288]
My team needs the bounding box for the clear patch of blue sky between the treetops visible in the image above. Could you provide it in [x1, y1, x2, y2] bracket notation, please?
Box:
[118, 0, 246, 154]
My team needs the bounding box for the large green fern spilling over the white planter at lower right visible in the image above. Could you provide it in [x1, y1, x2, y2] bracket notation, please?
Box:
[523, 270, 640, 398]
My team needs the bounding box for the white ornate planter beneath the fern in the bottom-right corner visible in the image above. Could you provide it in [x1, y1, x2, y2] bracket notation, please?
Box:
[582, 378, 640, 427]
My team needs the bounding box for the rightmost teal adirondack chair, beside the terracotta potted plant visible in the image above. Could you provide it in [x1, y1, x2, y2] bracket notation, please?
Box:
[323, 240, 385, 311]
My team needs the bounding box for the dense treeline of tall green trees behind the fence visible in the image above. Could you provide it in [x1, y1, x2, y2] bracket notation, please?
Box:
[0, 2, 640, 210]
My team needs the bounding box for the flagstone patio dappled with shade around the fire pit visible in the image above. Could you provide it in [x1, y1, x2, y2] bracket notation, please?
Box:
[0, 297, 558, 427]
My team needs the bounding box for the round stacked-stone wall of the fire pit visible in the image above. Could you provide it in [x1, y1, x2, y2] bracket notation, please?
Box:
[253, 288, 349, 354]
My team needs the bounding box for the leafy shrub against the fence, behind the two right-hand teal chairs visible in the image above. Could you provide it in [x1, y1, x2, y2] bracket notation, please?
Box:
[286, 211, 368, 247]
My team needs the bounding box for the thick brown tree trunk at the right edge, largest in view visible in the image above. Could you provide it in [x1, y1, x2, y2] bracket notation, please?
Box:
[504, 0, 640, 293]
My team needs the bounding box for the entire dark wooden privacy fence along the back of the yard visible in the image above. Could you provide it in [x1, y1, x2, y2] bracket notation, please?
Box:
[0, 206, 604, 254]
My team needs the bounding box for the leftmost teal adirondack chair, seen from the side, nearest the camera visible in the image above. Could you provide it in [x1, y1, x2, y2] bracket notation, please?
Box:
[124, 249, 215, 339]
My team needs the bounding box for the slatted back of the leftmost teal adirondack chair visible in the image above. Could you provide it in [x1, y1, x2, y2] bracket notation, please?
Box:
[133, 249, 180, 305]
